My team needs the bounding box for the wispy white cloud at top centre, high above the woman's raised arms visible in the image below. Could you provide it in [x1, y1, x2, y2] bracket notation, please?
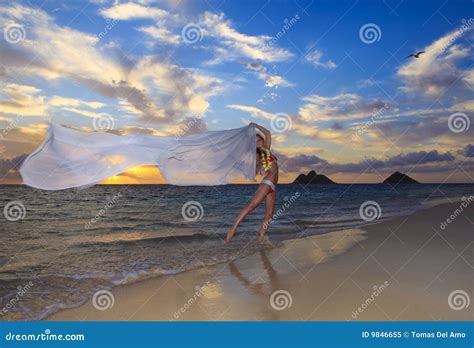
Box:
[199, 12, 293, 64]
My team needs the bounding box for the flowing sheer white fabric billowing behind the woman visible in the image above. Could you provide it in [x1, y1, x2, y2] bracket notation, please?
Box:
[20, 124, 256, 190]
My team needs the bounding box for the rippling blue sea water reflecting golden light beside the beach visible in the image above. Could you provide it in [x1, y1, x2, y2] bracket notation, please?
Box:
[0, 184, 474, 320]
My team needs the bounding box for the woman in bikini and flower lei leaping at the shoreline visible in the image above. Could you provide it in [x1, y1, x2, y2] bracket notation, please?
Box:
[226, 122, 278, 243]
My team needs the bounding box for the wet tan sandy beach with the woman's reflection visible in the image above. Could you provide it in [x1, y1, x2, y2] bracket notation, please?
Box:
[48, 202, 474, 321]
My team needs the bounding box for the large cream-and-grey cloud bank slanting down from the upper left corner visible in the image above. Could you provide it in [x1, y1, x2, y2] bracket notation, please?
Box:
[0, 4, 223, 123]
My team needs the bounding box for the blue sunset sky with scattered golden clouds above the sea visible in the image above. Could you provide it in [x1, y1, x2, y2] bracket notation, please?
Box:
[0, 0, 474, 184]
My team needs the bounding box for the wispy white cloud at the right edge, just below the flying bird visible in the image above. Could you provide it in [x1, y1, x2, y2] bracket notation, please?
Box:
[397, 26, 474, 96]
